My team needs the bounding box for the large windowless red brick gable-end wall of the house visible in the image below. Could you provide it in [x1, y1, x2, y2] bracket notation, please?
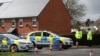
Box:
[38, 0, 71, 35]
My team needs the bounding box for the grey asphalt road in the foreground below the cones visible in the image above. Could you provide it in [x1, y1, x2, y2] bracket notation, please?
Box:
[18, 46, 100, 56]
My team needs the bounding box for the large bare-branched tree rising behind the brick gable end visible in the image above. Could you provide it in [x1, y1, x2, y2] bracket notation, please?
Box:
[63, 0, 86, 20]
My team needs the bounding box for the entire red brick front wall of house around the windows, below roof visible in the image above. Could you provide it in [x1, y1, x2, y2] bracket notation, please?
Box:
[0, 18, 38, 35]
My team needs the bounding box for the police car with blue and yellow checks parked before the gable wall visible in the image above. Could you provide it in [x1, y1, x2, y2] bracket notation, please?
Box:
[26, 31, 73, 49]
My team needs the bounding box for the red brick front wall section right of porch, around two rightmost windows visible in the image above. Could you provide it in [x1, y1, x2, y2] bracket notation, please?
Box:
[17, 18, 38, 34]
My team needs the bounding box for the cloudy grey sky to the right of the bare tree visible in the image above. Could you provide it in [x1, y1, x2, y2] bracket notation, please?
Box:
[80, 0, 100, 21]
